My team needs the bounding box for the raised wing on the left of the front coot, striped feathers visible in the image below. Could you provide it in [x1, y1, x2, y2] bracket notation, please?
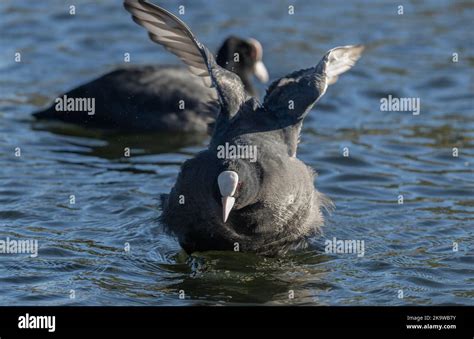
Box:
[124, 0, 217, 99]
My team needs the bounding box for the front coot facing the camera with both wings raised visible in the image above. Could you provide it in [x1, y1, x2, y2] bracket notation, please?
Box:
[125, 0, 363, 255]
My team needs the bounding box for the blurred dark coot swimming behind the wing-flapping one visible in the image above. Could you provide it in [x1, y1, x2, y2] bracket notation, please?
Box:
[34, 31, 268, 132]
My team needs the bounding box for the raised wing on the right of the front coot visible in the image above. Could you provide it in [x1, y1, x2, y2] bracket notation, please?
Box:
[263, 45, 364, 121]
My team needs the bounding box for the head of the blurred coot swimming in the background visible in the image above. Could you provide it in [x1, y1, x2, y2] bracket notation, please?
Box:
[216, 36, 269, 96]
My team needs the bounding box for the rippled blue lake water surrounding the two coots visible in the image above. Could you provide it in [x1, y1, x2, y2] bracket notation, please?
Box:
[0, 0, 474, 305]
